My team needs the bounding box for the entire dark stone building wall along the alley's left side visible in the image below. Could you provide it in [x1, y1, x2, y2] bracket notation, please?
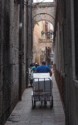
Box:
[0, 0, 31, 125]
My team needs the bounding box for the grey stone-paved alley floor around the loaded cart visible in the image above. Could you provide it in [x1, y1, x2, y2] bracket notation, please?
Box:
[5, 74, 65, 125]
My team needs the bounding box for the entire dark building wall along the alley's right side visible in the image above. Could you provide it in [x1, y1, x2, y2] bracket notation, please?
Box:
[54, 0, 78, 125]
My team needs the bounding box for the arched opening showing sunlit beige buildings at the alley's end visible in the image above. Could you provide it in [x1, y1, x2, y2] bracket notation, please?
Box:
[33, 20, 53, 64]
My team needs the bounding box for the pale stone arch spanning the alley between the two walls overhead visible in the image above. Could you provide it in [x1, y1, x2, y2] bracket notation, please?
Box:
[32, 2, 55, 26]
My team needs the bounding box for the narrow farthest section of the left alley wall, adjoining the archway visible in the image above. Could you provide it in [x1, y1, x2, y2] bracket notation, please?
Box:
[24, 0, 32, 87]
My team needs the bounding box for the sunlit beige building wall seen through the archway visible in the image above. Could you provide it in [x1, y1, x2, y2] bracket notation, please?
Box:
[33, 21, 52, 64]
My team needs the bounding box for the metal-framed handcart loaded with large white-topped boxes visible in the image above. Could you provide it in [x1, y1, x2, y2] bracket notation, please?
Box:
[32, 73, 53, 108]
